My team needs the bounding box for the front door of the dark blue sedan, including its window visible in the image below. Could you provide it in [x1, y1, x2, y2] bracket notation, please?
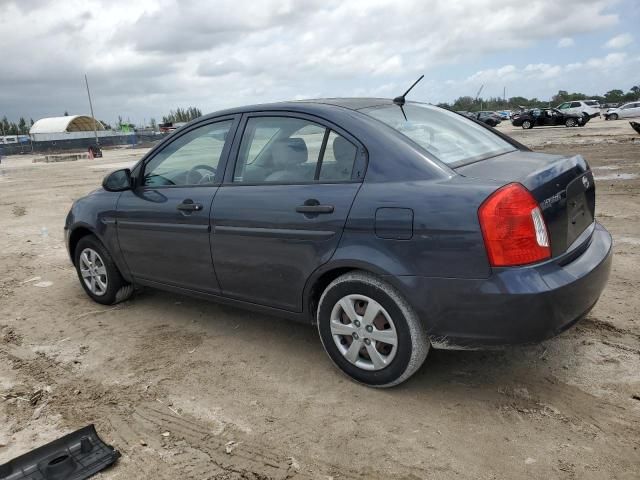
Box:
[117, 117, 239, 293]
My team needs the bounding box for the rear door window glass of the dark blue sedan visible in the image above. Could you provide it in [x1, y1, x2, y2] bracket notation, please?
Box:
[233, 117, 357, 184]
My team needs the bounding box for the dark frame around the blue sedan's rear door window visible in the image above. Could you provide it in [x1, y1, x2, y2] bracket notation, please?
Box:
[222, 110, 369, 187]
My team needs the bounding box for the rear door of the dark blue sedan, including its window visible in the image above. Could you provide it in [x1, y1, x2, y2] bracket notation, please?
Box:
[212, 113, 366, 311]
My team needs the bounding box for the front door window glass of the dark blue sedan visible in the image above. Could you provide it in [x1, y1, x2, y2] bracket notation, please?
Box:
[142, 120, 233, 187]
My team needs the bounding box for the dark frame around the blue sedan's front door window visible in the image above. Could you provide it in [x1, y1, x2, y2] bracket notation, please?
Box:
[132, 115, 241, 190]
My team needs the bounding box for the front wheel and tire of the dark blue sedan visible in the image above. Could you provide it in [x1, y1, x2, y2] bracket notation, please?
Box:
[74, 235, 133, 305]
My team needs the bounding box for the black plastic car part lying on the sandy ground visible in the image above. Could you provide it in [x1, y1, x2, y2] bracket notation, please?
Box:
[0, 425, 120, 480]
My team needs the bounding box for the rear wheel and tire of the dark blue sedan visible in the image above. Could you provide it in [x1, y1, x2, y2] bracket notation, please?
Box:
[316, 271, 430, 388]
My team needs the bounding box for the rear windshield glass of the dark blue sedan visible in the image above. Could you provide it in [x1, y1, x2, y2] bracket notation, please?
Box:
[361, 103, 516, 166]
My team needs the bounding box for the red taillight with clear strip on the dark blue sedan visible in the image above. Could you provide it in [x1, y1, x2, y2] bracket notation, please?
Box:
[478, 183, 551, 267]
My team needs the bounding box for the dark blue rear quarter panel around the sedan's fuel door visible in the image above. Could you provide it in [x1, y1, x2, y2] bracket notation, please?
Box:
[331, 175, 500, 278]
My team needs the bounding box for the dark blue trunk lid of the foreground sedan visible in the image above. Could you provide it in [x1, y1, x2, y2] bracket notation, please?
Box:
[455, 150, 595, 257]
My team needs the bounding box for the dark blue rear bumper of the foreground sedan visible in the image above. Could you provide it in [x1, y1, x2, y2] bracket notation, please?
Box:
[394, 223, 613, 348]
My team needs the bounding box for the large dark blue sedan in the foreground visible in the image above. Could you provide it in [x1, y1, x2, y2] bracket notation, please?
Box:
[64, 98, 612, 387]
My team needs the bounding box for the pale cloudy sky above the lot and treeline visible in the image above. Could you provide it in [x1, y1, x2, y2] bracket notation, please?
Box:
[0, 0, 640, 123]
